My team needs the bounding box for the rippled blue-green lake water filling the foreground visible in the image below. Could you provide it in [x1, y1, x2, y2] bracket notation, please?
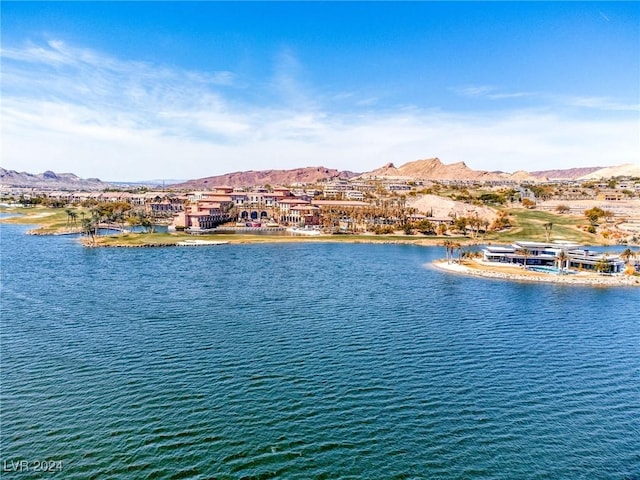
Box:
[0, 225, 640, 480]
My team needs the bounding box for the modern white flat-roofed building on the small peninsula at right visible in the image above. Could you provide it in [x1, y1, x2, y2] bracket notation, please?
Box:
[482, 241, 625, 273]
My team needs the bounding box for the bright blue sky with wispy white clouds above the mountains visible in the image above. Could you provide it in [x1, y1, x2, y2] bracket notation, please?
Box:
[0, 1, 640, 180]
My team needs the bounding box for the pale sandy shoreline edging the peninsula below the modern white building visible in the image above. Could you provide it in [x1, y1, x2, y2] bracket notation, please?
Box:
[431, 260, 640, 287]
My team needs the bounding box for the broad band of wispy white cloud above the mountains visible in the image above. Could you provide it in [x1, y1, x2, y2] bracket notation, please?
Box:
[2, 42, 640, 180]
